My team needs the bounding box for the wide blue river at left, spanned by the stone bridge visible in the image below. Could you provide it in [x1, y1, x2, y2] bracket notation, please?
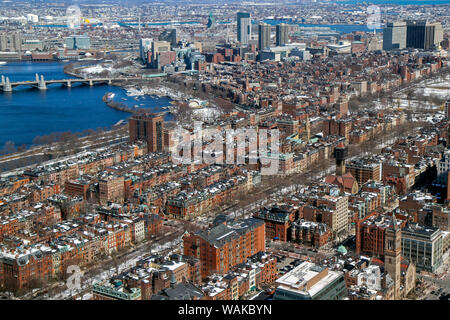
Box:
[0, 62, 170, 149]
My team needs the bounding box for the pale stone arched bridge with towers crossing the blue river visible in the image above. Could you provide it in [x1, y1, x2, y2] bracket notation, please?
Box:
[0, 74, 142, 92]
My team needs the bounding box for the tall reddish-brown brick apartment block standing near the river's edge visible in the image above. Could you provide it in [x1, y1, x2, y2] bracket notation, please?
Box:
[128, 114, 164, 152]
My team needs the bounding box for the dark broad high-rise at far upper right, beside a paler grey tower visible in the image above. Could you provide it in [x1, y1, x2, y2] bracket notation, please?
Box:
[406, 20, 443, 50]
